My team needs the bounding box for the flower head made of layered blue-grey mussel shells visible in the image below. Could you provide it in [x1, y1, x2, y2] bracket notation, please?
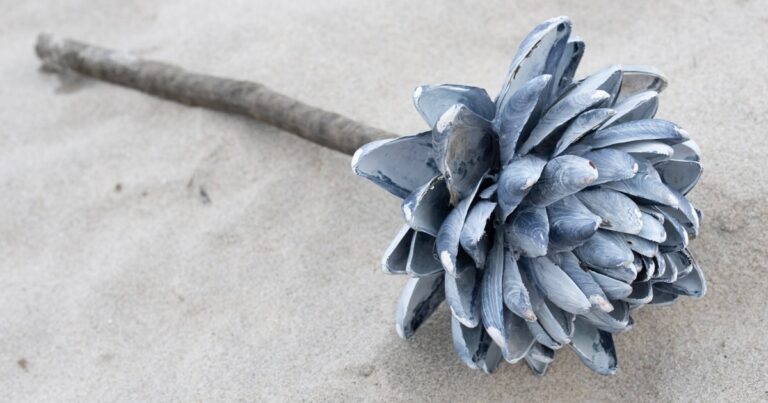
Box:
[352, 17, 706, 375]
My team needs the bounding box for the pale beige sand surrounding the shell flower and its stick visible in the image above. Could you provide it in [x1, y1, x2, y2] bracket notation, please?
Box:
[0, 0, 768, 402]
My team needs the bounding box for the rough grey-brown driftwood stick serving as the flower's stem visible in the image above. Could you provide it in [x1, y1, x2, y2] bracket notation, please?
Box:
[35, 34, 394, 154]
